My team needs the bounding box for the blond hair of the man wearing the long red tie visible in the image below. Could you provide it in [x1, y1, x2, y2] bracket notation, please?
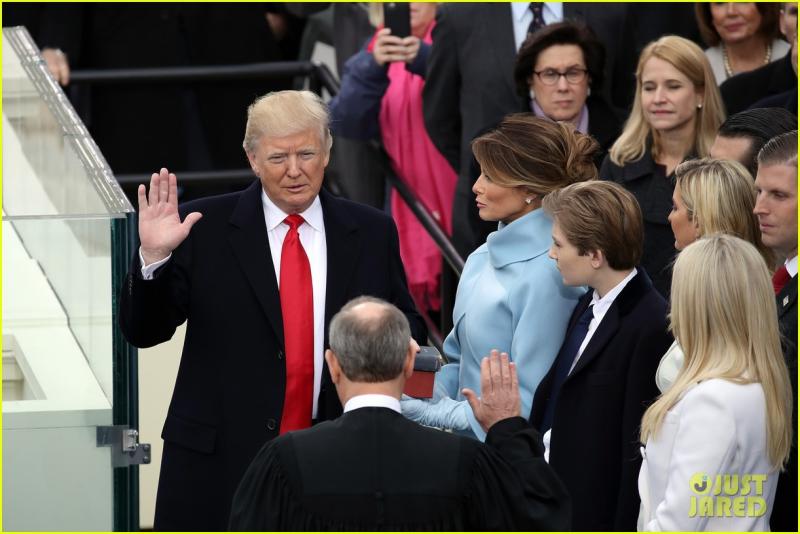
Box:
[242, 91, 333, 154]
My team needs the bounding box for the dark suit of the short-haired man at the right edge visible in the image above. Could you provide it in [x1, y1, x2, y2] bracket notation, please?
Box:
[769, 276, 797, 532]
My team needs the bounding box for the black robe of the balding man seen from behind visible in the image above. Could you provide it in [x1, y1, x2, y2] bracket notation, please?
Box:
[230, 407, 569, 532]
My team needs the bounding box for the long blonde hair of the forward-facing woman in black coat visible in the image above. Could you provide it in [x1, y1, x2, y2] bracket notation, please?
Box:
[609, 35, 725, 166]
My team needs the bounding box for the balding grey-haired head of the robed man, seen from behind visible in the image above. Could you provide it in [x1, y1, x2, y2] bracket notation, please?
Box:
[329, 297, 411, 383]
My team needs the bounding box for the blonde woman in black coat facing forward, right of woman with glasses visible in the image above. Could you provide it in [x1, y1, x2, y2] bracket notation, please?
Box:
[600, 35, 725, 297]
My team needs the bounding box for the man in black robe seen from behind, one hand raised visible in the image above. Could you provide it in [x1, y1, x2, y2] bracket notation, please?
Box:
[230, 298, 569, 531]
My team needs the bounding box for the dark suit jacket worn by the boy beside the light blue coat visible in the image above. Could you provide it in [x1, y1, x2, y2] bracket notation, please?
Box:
[531, 269, 672, 531]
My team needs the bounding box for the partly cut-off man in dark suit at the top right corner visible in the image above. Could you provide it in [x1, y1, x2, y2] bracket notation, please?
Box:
[719, 2, 797, 115]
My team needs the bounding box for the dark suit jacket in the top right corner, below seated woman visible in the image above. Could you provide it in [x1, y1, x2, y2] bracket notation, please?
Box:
[719, 52, 797, 116]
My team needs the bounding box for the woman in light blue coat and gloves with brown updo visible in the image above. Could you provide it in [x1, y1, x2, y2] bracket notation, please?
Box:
[401, 113, 598, 440]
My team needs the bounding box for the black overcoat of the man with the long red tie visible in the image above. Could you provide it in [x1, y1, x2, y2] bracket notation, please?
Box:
[120, 181, 426, 530]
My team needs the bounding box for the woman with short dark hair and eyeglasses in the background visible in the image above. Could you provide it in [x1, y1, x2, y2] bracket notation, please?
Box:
[514, 22, 622, 167]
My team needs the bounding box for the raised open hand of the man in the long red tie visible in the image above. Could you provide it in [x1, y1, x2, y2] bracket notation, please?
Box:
[138, 168, 203, 265]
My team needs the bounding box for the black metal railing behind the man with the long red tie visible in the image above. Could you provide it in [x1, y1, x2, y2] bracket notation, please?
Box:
[75, 61, 464, 351]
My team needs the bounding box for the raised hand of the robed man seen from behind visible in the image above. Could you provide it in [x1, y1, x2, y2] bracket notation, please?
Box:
[461, 350, 520, 432]
